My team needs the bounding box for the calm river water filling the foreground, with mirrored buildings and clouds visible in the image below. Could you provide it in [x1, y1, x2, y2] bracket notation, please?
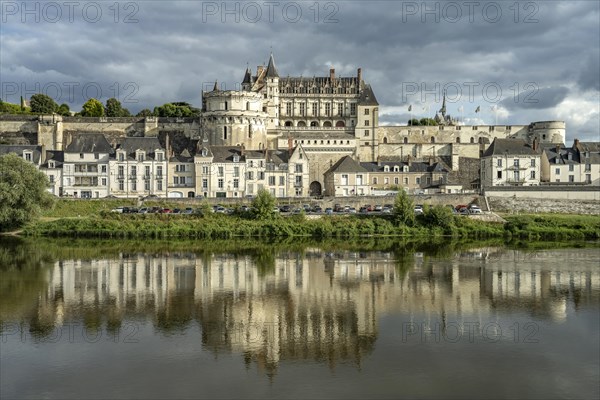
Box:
[0, 238, 600, 399]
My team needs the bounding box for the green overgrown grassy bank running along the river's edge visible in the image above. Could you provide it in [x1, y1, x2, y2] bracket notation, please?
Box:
[22, 212, 600, 240]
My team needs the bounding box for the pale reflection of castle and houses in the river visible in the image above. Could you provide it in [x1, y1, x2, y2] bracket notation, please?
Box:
[31, 248, 600, 369]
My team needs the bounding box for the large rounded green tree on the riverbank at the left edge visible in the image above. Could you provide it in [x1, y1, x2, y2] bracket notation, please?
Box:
[0, 153, 54, 231]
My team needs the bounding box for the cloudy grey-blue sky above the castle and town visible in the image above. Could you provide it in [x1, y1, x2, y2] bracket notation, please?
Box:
[0, 0, 600, 142]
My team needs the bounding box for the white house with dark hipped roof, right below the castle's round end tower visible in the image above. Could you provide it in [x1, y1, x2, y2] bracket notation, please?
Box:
[480, 138, 541, 189]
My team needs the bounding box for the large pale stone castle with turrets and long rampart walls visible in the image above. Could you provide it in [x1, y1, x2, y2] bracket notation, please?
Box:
[0, 54, 565, 195]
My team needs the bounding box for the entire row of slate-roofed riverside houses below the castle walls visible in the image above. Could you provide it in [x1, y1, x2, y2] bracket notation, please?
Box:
[0, 133, 600, 198]
